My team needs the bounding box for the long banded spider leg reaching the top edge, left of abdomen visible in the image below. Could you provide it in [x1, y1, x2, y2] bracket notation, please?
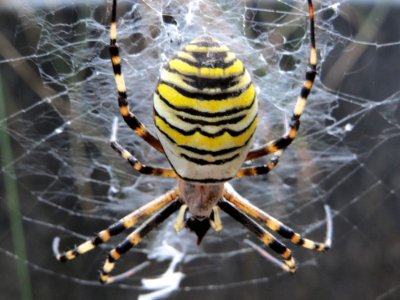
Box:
[109, 0, 164, 153]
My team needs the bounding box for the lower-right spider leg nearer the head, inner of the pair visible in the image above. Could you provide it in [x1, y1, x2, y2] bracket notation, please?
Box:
[218, 200, 296, 273]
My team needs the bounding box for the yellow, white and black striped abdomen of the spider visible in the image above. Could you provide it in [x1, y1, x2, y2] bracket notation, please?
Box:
[154, 36, 257, 183]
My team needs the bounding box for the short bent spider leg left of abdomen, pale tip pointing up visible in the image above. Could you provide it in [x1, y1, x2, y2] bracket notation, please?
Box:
[110, 118, 177, 178]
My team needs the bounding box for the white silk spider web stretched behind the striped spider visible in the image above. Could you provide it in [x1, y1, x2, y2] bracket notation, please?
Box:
[0, 0, 400, 300]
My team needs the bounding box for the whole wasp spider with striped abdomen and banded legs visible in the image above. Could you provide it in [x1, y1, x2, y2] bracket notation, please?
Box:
[57, 0, 331, 283]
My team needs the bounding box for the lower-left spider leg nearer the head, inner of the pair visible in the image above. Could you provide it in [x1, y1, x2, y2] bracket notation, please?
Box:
[99, 200, 182, 284]
